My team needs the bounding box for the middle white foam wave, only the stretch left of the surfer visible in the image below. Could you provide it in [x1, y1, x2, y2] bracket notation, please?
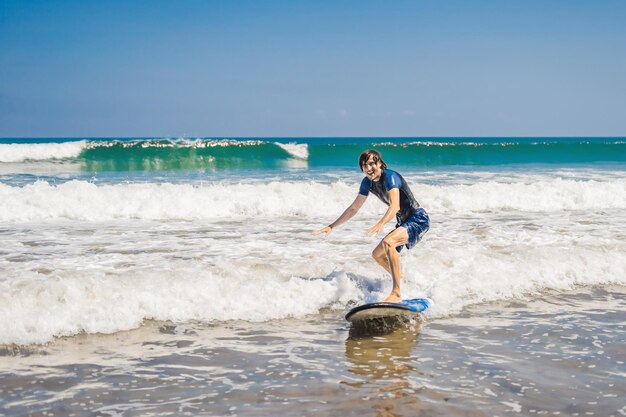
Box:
[0, 181, 356, 222]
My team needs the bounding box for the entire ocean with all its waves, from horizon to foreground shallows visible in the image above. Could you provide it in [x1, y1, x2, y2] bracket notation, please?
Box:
[0, 138, 626, 416]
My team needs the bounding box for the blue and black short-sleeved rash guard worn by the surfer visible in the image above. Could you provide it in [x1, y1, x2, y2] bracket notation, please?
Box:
[359, 169, 420, 224]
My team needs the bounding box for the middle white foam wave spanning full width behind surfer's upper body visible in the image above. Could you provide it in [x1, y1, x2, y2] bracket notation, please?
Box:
[0, 178, 626, 222]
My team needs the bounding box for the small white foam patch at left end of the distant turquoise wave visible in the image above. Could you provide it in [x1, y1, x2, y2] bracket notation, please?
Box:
[0, 140, 88, 162]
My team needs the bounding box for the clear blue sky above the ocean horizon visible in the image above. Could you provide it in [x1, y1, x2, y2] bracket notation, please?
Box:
[0, 0, 626, 137]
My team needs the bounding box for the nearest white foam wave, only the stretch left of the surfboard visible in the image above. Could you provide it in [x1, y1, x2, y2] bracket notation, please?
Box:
[0, 268, 355, 344]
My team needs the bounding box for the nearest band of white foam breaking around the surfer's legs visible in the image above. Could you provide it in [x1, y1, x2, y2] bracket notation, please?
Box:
[0, 225, 626, 344]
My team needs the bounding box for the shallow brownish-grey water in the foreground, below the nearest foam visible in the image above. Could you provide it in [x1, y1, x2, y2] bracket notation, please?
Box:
[0, 286, 626, 416]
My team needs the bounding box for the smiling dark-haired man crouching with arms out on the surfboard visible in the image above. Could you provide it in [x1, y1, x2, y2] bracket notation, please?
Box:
[313, 150, 430, 303]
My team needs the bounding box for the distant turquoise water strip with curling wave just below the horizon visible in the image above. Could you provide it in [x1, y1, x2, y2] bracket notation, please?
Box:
[0, 138, 626, 172]
